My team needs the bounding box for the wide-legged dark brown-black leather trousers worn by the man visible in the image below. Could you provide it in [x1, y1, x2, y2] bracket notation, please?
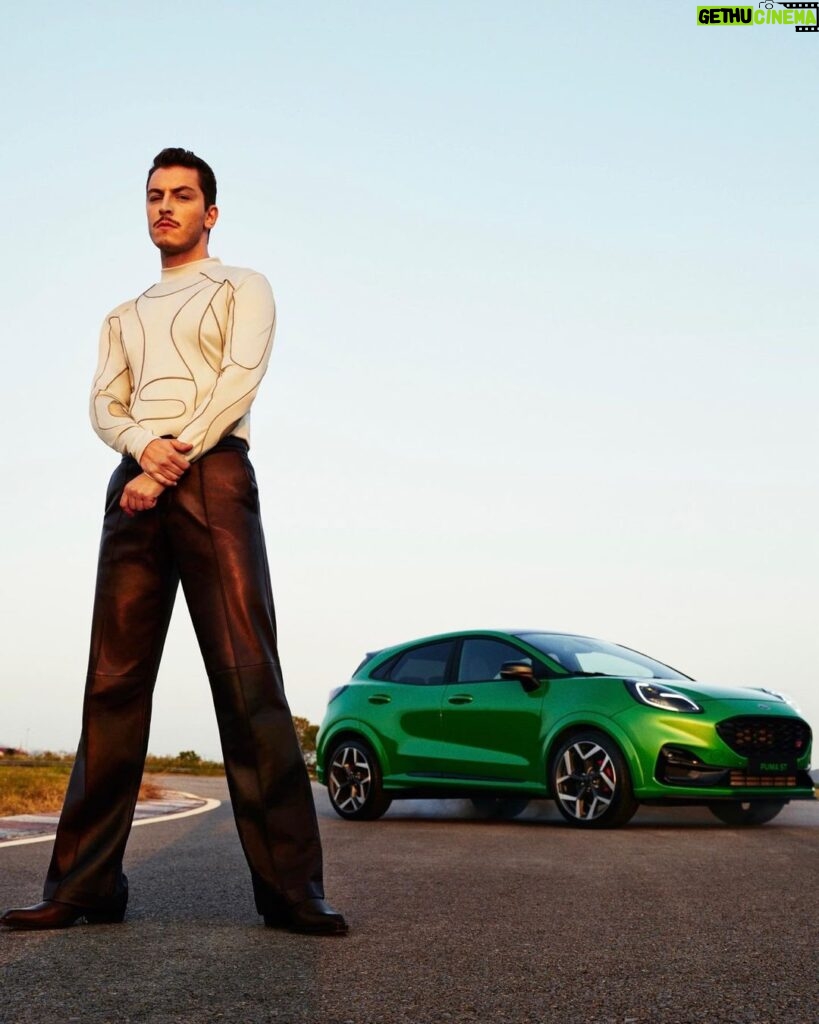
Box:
[44, 437, 324, 913]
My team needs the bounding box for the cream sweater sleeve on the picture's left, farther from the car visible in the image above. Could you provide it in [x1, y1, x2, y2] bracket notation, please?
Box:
[90, 311, 157, 462]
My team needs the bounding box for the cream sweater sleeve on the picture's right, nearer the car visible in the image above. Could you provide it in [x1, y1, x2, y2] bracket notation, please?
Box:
[177, 273, 275, 460]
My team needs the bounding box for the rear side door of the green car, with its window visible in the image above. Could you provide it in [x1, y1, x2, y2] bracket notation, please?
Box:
[361, 640, 455, 775]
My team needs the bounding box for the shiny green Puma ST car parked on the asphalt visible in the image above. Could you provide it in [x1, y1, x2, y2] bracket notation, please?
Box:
[316, 630, 814, 827]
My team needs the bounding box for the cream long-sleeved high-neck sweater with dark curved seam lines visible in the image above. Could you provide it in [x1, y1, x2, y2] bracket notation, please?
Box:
[91, 258, 275, 462]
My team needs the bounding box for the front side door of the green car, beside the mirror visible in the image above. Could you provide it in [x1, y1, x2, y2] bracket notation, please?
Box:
[442, 637, 548, 782]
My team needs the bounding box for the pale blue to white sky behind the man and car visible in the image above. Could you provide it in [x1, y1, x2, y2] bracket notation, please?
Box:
[0, 0, 819, 757]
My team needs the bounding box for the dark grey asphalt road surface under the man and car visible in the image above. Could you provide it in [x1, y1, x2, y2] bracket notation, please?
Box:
[0, 778, 819, 1024]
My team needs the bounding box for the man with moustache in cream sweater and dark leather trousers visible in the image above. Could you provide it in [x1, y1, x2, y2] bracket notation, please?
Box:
[0, 148, 347, 935]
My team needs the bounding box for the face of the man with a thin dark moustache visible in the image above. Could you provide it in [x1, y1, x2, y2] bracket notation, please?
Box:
[145, 167, 219, 256]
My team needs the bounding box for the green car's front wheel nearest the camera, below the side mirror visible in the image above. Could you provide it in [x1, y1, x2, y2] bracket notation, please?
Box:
[549, 729, 639, 828]
